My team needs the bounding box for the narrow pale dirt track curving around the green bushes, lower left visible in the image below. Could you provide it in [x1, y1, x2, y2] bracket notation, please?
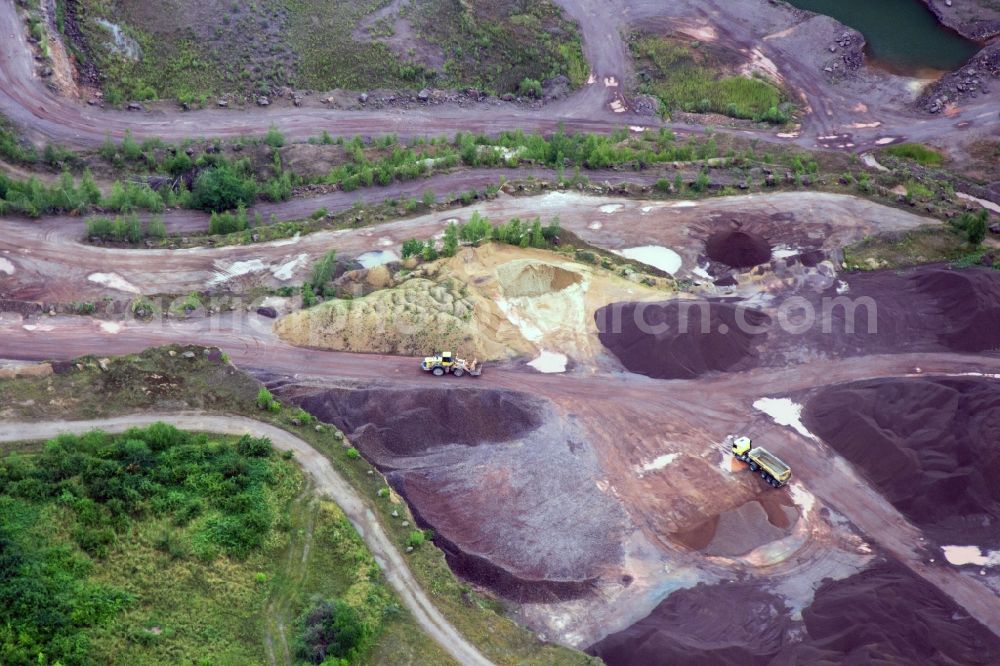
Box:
[0, 412, 492, 666]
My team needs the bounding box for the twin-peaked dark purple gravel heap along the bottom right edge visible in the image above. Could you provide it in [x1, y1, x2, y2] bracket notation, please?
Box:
[587, 560, 1000, 666]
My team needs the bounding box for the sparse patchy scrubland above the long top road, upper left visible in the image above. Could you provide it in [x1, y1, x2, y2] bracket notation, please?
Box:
[71, 0, 588, 105]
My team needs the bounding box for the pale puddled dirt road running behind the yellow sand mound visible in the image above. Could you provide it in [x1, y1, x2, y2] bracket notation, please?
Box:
[0, 192, 935, 303]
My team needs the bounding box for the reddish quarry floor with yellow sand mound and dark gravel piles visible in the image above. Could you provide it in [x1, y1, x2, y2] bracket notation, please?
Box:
[0, 187, 1000, 664]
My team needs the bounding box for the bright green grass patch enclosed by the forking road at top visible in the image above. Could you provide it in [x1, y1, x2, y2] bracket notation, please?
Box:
[629, 36, 790, 124]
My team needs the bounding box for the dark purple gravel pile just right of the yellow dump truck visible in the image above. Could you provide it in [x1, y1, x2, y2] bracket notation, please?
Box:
[803, 377, 1000, 546]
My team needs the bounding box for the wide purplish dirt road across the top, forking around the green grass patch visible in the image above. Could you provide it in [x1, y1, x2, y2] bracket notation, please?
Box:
[0, 0, 1000, 151]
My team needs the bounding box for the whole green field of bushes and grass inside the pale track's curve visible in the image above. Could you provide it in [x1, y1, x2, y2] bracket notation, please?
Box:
[0, 424, 426, 664]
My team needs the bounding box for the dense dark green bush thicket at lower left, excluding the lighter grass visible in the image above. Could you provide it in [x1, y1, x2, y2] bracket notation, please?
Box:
[0, 423, 284, 664]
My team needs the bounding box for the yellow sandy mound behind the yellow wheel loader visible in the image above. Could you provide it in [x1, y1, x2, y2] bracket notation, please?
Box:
[276, 245, 664, 360]
